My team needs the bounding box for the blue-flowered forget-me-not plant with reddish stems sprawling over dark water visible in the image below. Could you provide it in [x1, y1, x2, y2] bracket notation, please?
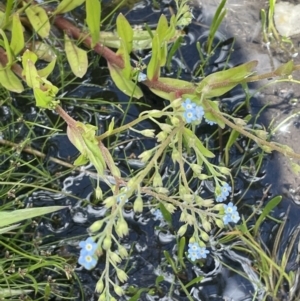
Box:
[0, 0, 300, 300]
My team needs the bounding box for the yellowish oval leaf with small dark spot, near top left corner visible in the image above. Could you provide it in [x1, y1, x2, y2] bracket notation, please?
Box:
[24, 3, 51, 39]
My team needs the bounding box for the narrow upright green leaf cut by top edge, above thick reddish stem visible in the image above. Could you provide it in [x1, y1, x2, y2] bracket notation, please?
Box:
[85, 0, 101, 47]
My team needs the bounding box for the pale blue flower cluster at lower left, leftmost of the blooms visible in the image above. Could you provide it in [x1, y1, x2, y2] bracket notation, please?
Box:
[78, 237, 98, 270]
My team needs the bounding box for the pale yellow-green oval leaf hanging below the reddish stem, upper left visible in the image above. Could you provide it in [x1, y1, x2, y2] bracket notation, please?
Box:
[65, 34, 88, 78]
